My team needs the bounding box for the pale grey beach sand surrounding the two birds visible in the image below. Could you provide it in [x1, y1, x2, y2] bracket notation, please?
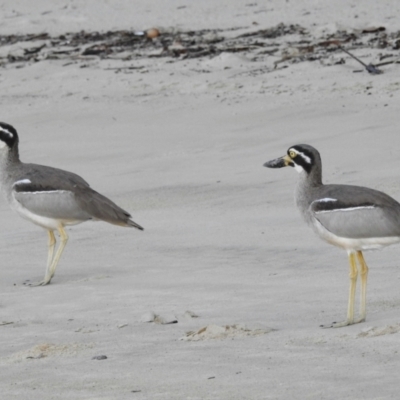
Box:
[0, 0, 400, 400]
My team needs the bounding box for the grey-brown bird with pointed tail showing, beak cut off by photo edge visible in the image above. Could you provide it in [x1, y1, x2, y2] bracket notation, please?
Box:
[0, 122, 143, 285]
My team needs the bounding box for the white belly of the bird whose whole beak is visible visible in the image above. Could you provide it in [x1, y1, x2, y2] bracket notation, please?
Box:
[313, 220, 400, 250]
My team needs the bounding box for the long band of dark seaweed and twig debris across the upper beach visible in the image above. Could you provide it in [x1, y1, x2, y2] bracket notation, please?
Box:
[0, 24, 400, 73]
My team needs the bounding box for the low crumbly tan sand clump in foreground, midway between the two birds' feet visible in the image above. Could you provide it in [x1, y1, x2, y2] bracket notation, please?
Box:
[180, 324, 275, 342]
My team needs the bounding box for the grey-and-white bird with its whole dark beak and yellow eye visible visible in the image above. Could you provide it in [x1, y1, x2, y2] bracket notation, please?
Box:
[264, 144, 400, 328]
